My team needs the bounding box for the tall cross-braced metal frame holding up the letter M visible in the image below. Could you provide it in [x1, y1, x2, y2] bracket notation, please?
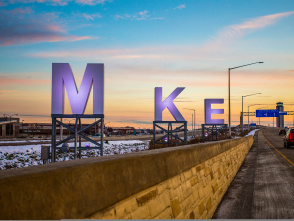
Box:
[51, 114, 104, 162]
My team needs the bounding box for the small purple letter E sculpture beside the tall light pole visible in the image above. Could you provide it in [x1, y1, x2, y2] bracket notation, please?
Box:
[204, 99, 224, 124]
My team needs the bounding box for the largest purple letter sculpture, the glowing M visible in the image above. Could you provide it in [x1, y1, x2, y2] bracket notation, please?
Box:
[51, 63, 104, 114]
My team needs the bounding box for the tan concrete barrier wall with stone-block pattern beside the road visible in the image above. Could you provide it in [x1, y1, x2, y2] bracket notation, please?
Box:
[0, 136, 253, 219]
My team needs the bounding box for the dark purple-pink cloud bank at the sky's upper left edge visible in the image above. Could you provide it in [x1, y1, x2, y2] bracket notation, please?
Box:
[0, 7, 91, 46]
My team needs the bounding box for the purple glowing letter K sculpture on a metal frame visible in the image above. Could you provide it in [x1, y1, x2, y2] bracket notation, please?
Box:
[155, 87, 185, 121]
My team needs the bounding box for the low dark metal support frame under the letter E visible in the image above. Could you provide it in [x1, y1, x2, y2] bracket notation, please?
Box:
[201, 124, 228, 141]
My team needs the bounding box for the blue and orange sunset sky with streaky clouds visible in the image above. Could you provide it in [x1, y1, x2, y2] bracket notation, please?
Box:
[0, 0, 294, 128]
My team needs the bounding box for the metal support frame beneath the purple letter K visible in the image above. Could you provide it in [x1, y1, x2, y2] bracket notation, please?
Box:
[153, 121, 187, 148]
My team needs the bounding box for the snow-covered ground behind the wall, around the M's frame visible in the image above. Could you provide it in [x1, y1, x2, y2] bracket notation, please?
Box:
[0, 140, 149, 170]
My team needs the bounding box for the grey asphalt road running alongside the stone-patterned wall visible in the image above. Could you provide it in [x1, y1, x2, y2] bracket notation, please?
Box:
[213, 128, 294, 219]
